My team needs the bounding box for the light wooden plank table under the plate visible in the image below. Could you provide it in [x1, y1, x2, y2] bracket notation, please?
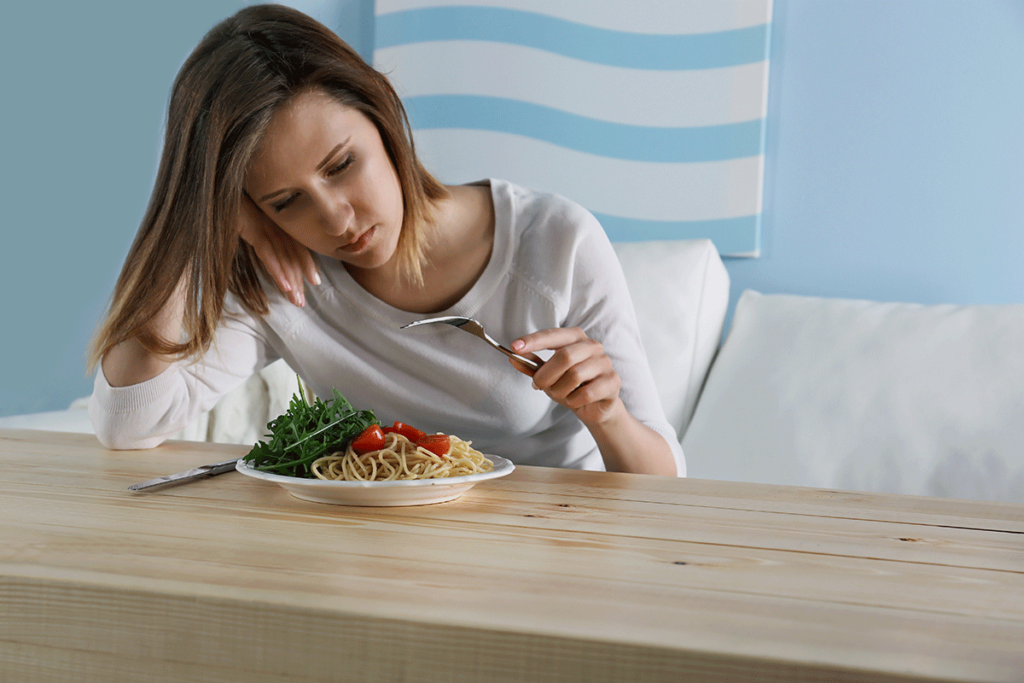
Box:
[0, 430, 1024, 683]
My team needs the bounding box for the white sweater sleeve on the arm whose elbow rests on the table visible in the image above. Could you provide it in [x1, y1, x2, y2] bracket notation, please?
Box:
[89, 296, 278, 450]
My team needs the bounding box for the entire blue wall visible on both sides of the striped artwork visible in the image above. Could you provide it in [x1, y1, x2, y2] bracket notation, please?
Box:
[0, 0, 1024, 415]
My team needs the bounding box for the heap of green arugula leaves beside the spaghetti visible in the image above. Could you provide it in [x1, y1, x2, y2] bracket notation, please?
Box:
[244, 381, 380, 479]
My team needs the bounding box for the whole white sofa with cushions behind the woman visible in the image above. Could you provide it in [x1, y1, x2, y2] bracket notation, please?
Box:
[0, 240, 1024, 503]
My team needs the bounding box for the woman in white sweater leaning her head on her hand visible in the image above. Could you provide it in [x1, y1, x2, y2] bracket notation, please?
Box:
[90, 5, 684, 475]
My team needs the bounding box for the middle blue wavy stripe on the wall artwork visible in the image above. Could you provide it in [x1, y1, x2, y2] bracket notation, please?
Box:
[404, 95, 764, 163]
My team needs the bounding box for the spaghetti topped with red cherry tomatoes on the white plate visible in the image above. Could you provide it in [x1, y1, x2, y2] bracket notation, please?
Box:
[311, 422, 494, 481]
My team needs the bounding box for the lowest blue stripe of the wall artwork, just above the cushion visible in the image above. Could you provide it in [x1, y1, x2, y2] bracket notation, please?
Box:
[594, 213, 761, 256]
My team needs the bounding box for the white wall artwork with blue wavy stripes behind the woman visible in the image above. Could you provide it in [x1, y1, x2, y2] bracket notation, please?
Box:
[374, 0, 771, 256]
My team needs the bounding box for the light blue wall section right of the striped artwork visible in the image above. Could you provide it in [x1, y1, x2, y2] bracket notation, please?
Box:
[727, 0, 1024, 315]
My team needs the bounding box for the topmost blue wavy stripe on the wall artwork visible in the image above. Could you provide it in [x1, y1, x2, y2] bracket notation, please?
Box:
[376, 7, 768, 71]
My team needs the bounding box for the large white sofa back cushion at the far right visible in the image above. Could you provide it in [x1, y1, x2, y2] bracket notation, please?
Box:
[683, 291, 1024, 503]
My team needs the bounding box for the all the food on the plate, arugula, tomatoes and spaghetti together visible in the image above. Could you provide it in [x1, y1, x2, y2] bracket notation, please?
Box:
[243, 381, 493, 481]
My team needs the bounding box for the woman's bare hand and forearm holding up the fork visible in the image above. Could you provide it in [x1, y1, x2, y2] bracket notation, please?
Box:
[511, 328, 678, 476]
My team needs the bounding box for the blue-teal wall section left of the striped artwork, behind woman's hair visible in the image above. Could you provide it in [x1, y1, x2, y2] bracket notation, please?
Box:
[0, 0, 373, 416]
